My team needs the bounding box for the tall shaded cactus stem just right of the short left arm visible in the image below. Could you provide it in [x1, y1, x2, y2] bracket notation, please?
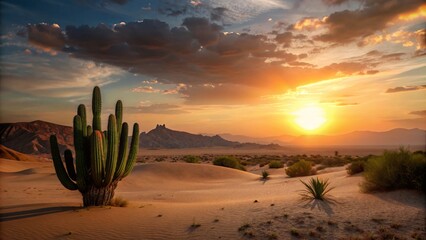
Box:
[73, 115, 88, 192]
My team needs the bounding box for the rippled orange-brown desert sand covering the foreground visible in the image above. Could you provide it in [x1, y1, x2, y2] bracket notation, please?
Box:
[0, 159, 426, 239]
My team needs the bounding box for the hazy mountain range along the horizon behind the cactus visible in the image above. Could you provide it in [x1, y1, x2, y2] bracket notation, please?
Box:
[0, 121, 426, 154]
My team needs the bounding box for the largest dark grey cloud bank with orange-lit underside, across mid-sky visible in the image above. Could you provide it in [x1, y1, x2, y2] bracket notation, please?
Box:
[28, 17, 383, 104]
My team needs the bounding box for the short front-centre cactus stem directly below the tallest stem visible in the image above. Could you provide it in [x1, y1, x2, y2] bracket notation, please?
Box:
[90, 130, 104, 187]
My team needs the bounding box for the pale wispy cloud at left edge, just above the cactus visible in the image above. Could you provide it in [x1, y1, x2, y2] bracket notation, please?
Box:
[1, 54, 124, 98]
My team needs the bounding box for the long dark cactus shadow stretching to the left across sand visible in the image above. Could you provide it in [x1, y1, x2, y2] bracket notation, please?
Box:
[0, 206, 80, 222]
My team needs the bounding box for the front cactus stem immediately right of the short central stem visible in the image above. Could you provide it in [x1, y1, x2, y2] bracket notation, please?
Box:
[104, 114, 119, 186]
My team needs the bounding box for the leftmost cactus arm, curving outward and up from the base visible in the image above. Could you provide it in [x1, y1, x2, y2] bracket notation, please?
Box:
[50, 135, 77, 190]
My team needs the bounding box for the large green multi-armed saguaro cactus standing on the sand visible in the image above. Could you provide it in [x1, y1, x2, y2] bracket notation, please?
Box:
[50, 87, 139, 206]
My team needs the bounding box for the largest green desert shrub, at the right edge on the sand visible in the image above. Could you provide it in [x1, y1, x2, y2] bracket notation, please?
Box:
[361, 148, 426, 192]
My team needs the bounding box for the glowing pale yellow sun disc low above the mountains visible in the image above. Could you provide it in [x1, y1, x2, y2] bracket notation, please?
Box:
[294, 106, 327, 131]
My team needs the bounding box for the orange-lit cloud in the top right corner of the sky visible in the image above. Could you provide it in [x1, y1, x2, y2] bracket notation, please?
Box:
[315, 0, 424, 44]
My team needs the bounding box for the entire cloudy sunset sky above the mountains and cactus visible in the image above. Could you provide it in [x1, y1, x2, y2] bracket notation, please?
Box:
[0, 0, 426, 137]
